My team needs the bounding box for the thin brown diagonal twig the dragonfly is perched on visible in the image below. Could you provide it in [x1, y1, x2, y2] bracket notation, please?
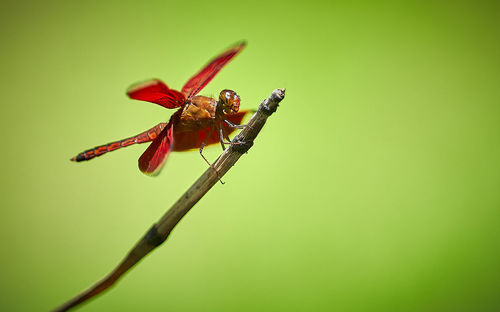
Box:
[54, 89, 285, 311]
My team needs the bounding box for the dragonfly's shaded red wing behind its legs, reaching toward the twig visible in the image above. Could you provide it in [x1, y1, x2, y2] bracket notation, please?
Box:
[173, 110, 250, 151]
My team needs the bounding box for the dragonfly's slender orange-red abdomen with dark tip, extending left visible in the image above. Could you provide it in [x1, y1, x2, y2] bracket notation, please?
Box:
[71, 122, 167, 162]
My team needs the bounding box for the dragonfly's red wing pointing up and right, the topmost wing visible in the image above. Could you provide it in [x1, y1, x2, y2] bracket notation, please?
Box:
[182, 42, 246, 99]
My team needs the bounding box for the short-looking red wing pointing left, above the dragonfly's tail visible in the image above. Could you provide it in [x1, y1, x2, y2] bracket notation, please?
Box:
[127, 79, 186, 108]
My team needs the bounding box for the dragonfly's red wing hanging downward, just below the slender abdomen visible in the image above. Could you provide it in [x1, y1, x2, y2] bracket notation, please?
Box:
[139, 123, 173, 175]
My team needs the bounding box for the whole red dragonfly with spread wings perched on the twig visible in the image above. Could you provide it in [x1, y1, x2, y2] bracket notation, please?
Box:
[71, 42, 250, 175]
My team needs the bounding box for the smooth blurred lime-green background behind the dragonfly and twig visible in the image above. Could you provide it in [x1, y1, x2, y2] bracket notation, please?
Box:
[0, 0, 500, 311]
